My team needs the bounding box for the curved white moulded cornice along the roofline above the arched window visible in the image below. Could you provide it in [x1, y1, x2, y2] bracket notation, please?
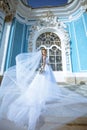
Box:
[10, 0, 87, 21]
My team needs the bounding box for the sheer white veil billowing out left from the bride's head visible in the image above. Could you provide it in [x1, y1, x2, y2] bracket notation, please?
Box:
[0, 51, 41, 96]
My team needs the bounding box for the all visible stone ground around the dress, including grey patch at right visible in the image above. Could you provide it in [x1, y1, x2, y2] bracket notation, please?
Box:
[0, 85, 87, 130]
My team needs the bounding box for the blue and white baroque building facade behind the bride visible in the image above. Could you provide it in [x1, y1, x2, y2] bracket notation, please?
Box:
[0, 0, 87, 84]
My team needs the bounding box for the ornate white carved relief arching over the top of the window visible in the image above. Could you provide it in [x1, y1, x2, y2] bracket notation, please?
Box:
[29, 15, 69, 49]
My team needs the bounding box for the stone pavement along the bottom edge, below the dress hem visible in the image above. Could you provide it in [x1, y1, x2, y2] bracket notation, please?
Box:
[0, 114, 87, 130]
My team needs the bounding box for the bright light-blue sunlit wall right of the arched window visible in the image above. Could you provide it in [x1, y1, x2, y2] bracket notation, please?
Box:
[70, 13, 87, 72]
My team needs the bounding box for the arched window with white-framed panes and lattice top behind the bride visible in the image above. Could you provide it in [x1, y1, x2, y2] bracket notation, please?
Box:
[36, 32, 63, 71]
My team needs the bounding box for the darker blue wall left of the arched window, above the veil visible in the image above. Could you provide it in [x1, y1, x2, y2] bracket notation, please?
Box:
[5, 18, 27, 70]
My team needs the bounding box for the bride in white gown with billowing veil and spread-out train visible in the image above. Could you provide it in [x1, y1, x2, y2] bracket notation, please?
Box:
[0, 48, 87, 130]
